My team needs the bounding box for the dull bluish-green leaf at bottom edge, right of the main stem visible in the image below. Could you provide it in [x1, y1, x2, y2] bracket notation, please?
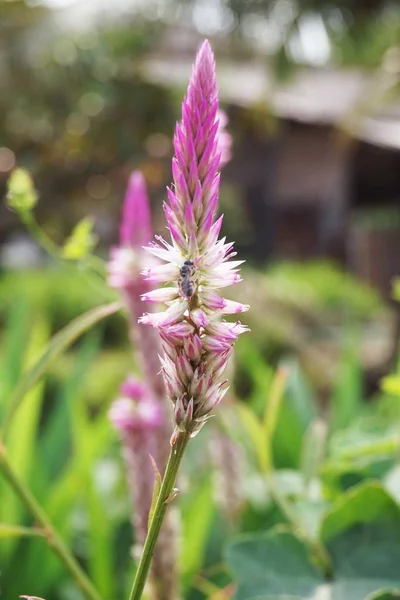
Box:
[227, 529, 324, 600]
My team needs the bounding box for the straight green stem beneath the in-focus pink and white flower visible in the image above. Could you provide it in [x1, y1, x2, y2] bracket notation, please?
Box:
[129, 432, 190, 600]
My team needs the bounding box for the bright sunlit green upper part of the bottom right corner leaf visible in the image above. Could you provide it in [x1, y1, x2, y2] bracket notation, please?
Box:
[320, 481, 400, 543]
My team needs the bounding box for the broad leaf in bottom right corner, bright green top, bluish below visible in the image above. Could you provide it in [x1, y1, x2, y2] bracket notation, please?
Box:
[321, 481, 400, 600]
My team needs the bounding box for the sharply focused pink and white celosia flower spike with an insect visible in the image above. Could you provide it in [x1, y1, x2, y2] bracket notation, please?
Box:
[140, 41, 248, 434]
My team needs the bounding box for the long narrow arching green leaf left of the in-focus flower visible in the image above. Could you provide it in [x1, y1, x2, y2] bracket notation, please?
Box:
[3, 302, 121, 434]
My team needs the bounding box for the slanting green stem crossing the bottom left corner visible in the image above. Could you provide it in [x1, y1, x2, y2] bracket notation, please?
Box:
[0, 441, 101, 600]
